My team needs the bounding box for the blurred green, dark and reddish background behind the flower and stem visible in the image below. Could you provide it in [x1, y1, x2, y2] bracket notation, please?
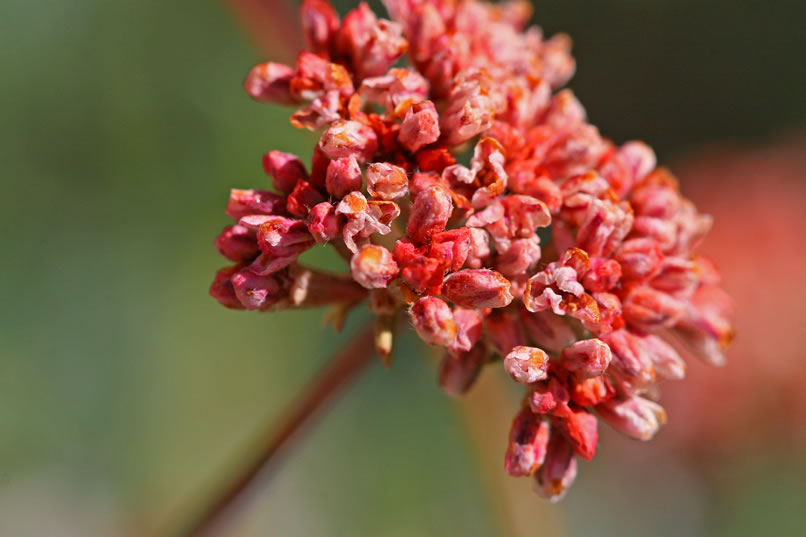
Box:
[0, 0, 806, 537]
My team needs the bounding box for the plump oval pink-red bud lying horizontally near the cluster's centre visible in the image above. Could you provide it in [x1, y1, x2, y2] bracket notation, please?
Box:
[443, 269, 513, 308]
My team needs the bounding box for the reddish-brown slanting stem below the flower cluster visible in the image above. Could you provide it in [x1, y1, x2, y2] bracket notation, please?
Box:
[174, 323, 375, 537]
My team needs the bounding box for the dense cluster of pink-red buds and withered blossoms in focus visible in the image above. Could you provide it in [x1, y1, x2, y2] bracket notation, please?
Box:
[211, 0, 732, 499]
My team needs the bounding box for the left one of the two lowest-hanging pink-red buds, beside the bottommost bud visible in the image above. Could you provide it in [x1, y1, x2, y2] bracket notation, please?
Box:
[504, 407, 549, 477]
